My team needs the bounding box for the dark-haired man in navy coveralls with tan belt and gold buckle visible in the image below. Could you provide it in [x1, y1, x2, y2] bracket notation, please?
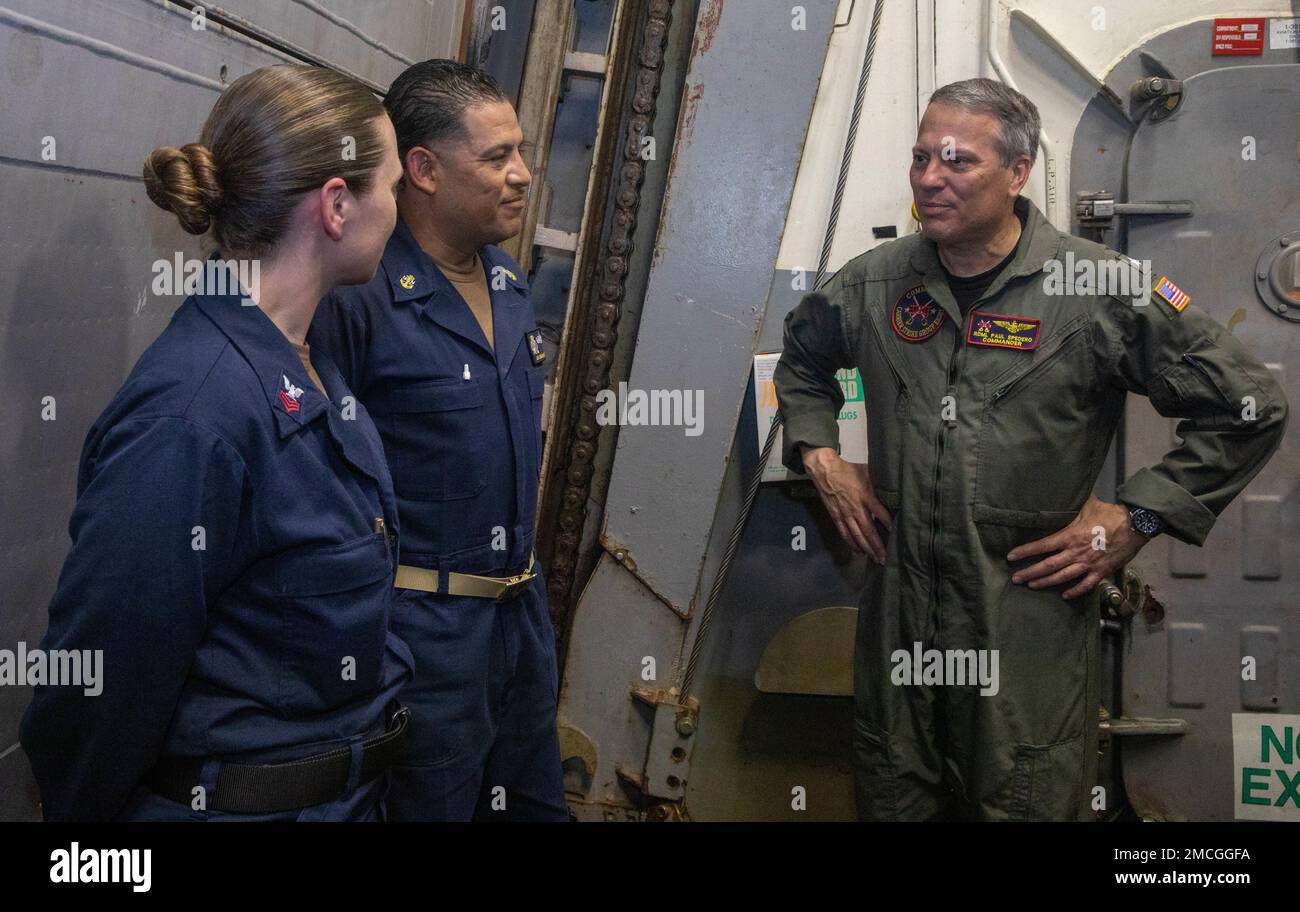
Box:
[309, 60, 568, 820]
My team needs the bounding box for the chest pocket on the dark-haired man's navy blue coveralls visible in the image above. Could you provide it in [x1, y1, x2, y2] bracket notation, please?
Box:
[385, 378, 488, 500]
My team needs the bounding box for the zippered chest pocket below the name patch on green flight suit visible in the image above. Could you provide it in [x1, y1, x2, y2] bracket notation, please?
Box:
[967, 321, 1106, 513]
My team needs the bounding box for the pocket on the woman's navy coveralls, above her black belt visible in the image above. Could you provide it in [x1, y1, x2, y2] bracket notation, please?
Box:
[273, 533, 393, 712]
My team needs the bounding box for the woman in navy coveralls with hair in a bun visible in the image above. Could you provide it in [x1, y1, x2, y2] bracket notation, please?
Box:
[22, 65, 412, 820]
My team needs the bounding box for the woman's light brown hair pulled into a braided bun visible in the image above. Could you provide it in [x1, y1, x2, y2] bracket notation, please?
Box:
[144, 64, 386, 257]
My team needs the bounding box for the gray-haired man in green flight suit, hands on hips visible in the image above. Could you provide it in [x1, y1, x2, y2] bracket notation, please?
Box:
[775, 79, 1287, 820]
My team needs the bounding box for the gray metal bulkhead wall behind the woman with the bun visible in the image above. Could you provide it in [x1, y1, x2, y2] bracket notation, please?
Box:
[0, 0, 463, 820]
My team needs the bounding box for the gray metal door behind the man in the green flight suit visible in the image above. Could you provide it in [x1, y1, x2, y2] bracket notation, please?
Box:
[1123, 53, 1300, 820]
